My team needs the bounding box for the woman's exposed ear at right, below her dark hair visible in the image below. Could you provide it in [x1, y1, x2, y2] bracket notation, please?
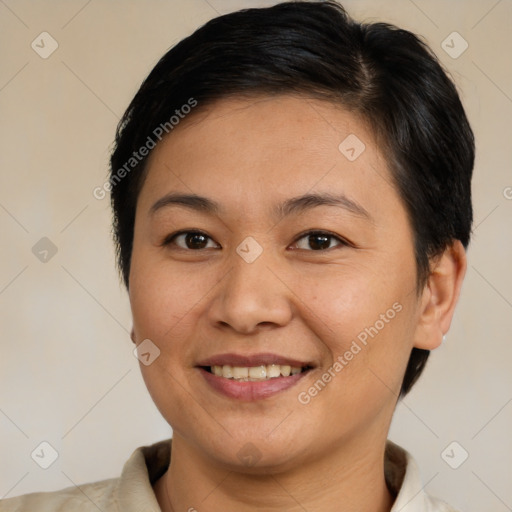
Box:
[413, 240, 467, 350]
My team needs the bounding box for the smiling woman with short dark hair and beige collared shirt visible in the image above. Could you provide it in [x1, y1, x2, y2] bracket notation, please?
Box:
[0, 1, 474, 512]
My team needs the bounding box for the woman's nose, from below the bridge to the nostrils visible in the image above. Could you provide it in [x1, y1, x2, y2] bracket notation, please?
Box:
[209, 249, 293, 334]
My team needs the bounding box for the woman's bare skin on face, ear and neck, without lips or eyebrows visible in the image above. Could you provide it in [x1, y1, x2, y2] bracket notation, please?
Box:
[129, 95, 466, 512]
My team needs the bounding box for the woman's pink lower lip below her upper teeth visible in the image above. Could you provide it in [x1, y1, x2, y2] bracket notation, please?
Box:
[199, 368, 309, 402]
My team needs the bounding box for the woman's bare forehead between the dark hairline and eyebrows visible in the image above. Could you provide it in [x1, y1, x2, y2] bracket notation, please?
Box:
[139, 95, 398, 220]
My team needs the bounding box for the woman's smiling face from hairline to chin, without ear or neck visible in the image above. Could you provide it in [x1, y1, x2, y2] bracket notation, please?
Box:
[129, 96, 426, 468]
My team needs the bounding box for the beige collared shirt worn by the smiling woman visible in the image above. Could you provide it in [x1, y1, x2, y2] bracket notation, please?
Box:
[0, 439, 456, 512]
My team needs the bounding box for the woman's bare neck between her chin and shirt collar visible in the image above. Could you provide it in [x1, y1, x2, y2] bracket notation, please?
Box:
[154, 434, 394, 512]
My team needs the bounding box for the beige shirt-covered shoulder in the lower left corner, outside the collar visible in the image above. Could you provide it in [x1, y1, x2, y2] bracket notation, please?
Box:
[0, 478, 119, 512]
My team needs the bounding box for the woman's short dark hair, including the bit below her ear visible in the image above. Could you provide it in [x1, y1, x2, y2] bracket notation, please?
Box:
[109, 1, 475, 396]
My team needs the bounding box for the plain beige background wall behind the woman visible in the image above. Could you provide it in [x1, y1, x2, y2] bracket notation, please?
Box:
[0, 0, 512, 512]
